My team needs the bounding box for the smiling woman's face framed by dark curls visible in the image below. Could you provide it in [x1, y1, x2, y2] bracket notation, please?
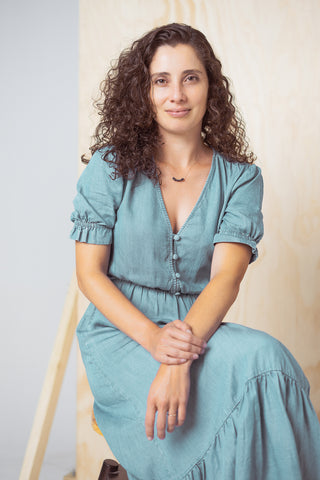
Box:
[149, 44, 209, 139]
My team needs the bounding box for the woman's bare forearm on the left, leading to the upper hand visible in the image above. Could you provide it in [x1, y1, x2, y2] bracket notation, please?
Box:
[78, 272, 159, 351]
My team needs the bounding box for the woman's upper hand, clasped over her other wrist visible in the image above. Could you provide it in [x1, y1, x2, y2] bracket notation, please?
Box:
[150, 320, 207, 365]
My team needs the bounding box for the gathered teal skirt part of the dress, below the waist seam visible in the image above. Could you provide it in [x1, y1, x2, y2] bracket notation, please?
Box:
[77, 281, 320, 480]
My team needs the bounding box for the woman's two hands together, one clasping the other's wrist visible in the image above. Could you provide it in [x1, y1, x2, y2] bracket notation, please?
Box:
[145, 320, 207, 440]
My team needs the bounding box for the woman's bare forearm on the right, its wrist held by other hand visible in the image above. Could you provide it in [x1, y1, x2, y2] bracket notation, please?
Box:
[184, 273, 240, 341]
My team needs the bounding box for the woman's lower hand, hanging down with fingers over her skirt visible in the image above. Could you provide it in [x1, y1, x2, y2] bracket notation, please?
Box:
[145, 362, 192, 440]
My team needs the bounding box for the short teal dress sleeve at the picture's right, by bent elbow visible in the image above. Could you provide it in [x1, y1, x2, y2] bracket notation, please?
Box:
[213, 165, 263, 263]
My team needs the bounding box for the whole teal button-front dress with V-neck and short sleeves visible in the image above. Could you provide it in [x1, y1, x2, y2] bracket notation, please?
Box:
[71, 151, 320, 480]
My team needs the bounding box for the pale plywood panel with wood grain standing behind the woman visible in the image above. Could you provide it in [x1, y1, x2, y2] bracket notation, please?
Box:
[78, 0, 320, 480]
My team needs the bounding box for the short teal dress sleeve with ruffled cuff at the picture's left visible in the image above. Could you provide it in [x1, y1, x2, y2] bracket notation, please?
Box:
[70, 150, 123, 245]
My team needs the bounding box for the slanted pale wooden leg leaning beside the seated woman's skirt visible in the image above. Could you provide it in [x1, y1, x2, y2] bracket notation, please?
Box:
[19, 272, 78, 480]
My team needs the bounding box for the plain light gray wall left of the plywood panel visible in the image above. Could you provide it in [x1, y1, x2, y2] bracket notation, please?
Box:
[0, 0, 78, 480]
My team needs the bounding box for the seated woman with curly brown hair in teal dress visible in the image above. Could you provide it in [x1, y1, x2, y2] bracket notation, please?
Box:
[71, 24, 320, 480]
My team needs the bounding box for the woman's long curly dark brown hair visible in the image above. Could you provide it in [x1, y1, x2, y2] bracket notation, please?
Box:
[82, 23, 255, 181]
